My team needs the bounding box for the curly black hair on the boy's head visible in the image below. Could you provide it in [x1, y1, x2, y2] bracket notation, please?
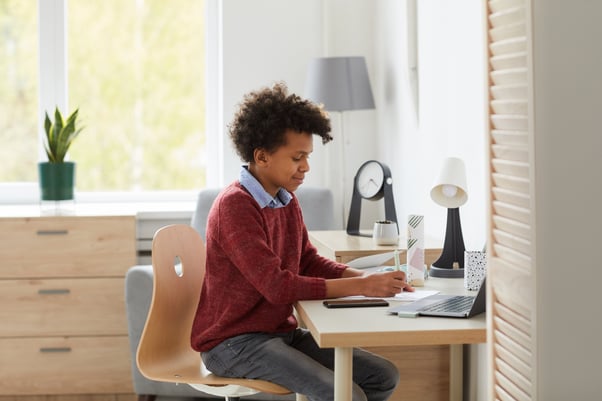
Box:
[229, 82, 332, 162]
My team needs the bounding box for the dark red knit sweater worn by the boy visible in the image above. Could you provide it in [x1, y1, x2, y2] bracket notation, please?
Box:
[191, 182, 346, 352]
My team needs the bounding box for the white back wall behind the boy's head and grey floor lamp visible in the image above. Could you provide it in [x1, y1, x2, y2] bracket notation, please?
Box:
[210, 0, 376, 228]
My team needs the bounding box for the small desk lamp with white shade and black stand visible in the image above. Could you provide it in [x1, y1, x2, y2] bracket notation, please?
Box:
[429, 157, 468, 278]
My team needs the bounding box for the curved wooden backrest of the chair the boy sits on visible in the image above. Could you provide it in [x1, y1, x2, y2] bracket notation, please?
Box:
[136, 224, 205, 383]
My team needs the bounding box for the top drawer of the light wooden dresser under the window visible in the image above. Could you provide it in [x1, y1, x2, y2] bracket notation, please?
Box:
[0, 216, 136, 278]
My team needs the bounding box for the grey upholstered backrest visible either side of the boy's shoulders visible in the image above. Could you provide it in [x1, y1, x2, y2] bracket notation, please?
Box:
[190, 186, 340, 239]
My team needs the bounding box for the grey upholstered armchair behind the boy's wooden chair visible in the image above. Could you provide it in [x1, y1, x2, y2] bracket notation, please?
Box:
[125, 187, 337, 401]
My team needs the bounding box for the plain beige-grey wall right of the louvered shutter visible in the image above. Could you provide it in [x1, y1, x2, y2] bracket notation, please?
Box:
[532, 0, 602, 401]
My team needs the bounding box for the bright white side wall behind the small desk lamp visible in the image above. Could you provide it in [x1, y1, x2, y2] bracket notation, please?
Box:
[376, 0, 487, 249]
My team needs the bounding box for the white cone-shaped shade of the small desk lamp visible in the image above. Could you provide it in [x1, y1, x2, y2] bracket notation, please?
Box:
[431, 157, 468, 208]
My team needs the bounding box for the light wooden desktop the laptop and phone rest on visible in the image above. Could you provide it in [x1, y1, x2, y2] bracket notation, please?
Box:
[296, 278, 486, 347]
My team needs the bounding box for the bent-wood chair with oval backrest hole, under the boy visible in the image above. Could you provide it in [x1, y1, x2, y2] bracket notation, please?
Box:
[136, 224, 291, 400]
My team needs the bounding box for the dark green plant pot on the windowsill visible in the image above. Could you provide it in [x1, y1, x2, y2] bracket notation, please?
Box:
[38, 162, 75, 201]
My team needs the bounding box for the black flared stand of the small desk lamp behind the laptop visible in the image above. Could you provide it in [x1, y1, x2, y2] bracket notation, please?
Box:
[429, 207, 466, 278]
